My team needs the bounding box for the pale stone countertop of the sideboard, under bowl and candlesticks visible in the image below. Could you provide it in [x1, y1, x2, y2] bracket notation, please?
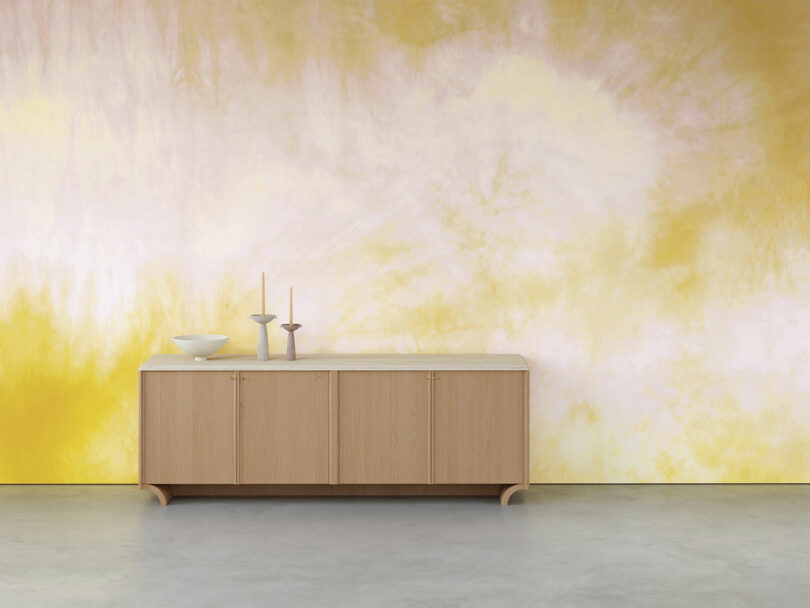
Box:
[138, 355, 529, 372]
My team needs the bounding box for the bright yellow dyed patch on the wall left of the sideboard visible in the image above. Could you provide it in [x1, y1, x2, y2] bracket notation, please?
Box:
[0, 290, 140, 483]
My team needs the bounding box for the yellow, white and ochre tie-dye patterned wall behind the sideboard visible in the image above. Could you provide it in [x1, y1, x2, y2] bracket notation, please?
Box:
[0, 0, 810, 483]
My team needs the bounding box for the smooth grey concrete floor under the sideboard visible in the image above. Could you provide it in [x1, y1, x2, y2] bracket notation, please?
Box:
[0, 486, 810, 608]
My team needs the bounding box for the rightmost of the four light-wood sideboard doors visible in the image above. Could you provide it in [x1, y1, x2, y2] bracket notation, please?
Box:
[433, 371, 526, 483]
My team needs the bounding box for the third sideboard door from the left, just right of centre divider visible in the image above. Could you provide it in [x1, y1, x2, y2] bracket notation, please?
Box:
[338, 371, 429, 484]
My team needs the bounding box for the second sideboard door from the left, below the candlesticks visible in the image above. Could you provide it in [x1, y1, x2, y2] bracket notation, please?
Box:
[239, 371, 329, 484]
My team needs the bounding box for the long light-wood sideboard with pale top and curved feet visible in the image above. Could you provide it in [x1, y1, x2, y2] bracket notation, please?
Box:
[139, 355, 529, 505]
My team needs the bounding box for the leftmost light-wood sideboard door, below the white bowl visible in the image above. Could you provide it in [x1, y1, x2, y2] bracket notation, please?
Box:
[141, 371, 236, 484]
